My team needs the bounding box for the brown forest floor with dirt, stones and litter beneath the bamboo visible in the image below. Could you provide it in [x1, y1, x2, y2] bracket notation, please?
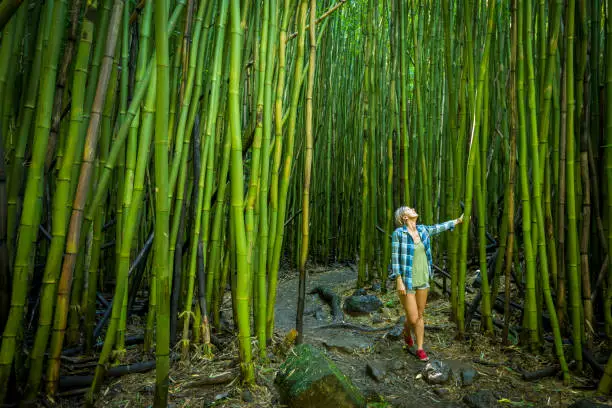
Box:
[60, 265, 612, 408]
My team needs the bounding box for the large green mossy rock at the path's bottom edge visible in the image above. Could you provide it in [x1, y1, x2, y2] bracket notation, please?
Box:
[275, 344, 366, 408]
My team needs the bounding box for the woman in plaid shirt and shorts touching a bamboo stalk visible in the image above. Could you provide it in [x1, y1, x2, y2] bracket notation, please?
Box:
[389, 207, 463, 361]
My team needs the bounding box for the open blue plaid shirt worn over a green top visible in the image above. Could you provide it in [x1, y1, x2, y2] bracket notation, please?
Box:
[389, 220, 455, 290]
